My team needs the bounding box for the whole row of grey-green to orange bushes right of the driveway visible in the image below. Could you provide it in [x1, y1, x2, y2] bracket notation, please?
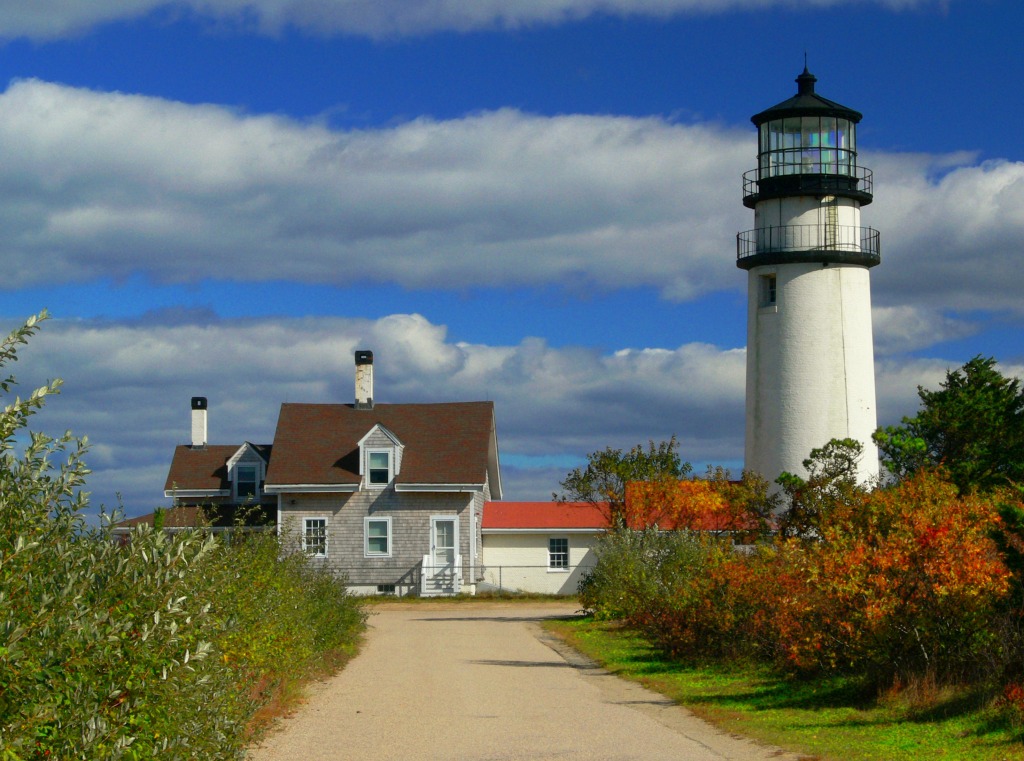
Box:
[582, 471, 1019, 683]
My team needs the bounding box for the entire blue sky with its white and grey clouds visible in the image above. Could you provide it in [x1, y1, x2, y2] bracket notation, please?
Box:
[0, 0, 1024, 514]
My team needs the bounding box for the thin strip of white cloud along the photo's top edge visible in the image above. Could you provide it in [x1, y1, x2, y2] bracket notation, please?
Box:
[0, 0, 948, 39]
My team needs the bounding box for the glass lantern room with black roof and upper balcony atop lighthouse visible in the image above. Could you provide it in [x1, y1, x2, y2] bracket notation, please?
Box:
[743, 67, 873, 209]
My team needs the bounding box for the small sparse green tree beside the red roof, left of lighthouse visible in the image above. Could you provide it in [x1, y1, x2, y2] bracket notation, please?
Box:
[552, 436, 693, 527]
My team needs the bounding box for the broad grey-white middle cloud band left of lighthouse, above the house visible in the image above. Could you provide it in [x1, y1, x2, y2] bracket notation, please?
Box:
[0, 81, 751, 298]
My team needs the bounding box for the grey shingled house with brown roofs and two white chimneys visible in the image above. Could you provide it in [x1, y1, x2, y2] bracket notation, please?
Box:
[165, 351, 502, 595]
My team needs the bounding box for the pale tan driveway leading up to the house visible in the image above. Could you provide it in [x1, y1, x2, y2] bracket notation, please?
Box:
[250, 602, 798, 761]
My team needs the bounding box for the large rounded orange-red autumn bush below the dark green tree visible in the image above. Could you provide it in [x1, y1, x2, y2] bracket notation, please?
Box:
[793, 471, 1009, 680]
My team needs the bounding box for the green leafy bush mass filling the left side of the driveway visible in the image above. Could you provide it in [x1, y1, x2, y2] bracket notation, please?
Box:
[0, 313, 365, 761]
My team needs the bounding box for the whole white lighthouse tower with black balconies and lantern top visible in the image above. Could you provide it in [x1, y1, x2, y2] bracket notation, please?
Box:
[736, 67, 880, 482]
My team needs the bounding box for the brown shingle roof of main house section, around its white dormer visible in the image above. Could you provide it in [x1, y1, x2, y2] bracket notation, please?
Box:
[266, 401, 501, 498]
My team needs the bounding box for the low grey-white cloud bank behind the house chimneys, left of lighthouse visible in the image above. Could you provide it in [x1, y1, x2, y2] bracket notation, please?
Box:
[5, 314, 744, 513]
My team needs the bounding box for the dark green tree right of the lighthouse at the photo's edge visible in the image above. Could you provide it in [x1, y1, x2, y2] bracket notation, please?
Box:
[873, 355, 1024, 493]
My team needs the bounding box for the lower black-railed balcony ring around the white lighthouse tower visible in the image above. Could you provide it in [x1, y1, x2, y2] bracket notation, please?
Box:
[736, 224, 882, 269]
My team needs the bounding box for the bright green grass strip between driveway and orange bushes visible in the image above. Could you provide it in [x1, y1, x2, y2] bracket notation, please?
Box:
[546, 619, 1024, 761]
